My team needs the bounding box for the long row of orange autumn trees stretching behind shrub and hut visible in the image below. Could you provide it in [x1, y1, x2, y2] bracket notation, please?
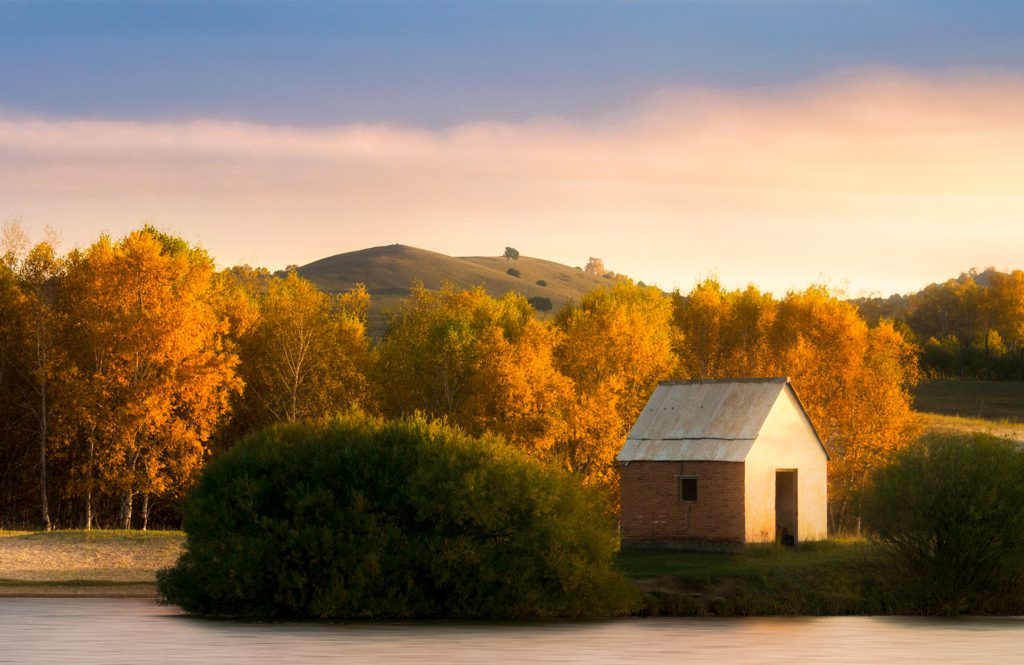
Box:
[0, 227, 916, 528]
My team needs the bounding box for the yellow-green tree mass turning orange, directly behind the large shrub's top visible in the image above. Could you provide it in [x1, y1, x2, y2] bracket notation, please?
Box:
[375, 285, 570, 457]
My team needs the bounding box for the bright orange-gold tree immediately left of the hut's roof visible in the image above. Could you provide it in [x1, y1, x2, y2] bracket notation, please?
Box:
[555, 279, 677, 487]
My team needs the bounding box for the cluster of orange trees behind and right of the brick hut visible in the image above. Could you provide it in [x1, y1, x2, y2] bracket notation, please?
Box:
[674, 280, 918, 530]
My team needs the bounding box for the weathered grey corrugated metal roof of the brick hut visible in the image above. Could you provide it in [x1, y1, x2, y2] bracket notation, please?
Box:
[616, 378, 787, 462]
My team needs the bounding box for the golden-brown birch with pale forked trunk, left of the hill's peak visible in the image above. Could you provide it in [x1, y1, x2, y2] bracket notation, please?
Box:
[228, 268, 370, 434]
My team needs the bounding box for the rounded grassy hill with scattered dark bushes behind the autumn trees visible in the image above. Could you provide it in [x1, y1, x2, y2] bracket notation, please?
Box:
[299, 245, 609, 336]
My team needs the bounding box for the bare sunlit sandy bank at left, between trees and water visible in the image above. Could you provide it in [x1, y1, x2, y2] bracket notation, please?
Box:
[0, 531, 184, 596]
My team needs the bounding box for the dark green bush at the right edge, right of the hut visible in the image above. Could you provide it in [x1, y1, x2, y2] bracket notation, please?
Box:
[863, 434, 1024, 614]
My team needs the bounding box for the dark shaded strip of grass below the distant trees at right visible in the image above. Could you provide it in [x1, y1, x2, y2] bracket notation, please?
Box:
[913, 379, 1024, 423]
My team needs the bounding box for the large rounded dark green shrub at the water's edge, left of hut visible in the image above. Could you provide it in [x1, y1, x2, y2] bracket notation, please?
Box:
[158, 418, 635, 618]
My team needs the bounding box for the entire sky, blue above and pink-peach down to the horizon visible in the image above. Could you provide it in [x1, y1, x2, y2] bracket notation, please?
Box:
[0, 2, 1024, 295]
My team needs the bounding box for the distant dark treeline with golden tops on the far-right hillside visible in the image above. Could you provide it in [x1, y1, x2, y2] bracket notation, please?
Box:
[853, 268, 1024, 381]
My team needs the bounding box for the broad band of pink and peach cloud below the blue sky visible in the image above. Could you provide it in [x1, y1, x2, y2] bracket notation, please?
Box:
[6, 71, 1024, 291]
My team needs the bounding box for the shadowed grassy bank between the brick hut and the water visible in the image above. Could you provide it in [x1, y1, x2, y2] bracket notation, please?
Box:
[617, 540, 889, 616]
